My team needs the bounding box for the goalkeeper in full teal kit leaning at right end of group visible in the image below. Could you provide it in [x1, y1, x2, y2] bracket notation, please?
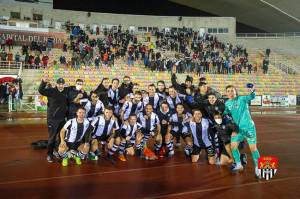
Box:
[224, 85, 260, 177]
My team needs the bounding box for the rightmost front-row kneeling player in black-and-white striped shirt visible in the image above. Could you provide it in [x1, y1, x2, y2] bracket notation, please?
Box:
[183, 109, 216, 164]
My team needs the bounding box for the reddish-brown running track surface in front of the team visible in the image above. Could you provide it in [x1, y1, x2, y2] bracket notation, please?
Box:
[0, 115, 300, 199]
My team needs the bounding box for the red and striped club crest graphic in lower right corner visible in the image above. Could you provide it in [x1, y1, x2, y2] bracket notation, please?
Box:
[258, 156, 278, 180]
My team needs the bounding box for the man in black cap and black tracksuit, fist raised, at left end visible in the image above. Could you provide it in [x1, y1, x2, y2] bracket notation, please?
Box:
[39, 78, 68, 162]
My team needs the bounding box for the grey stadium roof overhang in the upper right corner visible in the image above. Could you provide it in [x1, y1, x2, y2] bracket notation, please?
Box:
[170, 0, 300, 32]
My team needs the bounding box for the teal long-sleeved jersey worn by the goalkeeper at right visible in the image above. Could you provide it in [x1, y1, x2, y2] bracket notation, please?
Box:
[224, 92, 255, 131]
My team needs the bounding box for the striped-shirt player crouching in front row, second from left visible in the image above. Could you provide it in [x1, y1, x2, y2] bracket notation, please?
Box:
[90, 107, 120, 160]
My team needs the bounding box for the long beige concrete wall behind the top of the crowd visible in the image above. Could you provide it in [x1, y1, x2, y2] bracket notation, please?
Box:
[0, 0, 236, 37]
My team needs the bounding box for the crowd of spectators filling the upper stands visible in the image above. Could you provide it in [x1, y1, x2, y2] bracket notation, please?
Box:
[0, 25, 269, 75]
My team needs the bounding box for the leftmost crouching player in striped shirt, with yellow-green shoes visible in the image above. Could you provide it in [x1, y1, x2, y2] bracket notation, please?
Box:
[58, 107, 94, 166]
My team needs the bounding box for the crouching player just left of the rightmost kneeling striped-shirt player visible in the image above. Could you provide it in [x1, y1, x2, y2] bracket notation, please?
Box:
[165, 104, 193, 156]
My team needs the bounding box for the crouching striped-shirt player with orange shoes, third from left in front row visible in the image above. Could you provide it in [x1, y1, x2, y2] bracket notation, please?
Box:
[119, 114, 143, 162]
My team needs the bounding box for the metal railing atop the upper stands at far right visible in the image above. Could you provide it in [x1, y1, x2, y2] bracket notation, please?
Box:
[236, 32, 300, 39]
